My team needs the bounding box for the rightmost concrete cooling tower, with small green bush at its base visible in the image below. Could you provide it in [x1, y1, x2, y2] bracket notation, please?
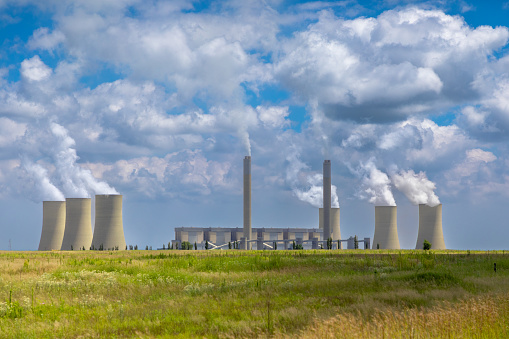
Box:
[415, 204, 445, 250]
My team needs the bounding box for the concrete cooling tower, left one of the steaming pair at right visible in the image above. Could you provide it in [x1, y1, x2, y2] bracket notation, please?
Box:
[373, 206, 400, 250]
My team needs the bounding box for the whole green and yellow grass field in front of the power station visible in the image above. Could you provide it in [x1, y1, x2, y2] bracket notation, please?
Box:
[0, 250, 509, 338]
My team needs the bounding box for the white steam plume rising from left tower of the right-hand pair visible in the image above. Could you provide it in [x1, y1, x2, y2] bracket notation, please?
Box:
[356, 159, 396, 206]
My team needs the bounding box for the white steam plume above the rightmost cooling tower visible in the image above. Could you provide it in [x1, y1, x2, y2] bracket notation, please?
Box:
[391, 170, 440, 207]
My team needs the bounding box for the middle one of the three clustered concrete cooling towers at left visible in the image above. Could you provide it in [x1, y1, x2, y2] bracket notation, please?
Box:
[61, 198, 92, 251]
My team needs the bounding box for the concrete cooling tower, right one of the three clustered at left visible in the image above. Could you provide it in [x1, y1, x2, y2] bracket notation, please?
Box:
[92, 194, 125, 250]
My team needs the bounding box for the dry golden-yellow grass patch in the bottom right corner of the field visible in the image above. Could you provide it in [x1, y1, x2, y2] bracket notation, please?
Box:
[298, 294, 509, 338]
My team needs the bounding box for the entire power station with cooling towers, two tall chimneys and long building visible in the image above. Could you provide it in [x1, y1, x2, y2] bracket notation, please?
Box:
[39, 156, 445, 251]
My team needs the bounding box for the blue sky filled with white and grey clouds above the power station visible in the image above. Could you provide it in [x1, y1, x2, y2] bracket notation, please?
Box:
[0, 0, 509, 250]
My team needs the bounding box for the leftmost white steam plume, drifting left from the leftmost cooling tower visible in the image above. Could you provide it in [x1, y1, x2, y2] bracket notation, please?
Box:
[21, 157, 65, 201]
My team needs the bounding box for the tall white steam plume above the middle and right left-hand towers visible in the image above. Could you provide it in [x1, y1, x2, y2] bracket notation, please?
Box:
[50, 123, 118, 198]
